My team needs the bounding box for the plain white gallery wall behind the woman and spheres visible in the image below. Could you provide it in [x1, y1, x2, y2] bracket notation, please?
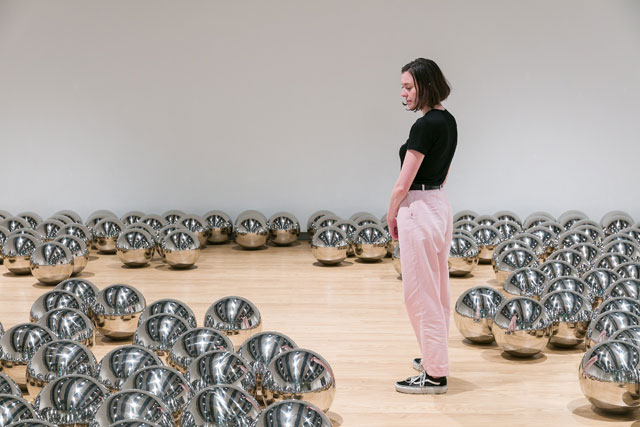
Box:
[0, 0, 640, 224]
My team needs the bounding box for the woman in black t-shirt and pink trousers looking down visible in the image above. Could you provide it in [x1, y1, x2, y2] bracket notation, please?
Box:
[387, 58, 458, 394]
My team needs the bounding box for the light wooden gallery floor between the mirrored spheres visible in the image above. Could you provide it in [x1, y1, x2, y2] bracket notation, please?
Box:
[0, 241, 640, 427]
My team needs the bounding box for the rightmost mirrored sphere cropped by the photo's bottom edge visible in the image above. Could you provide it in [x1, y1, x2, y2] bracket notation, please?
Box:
[256, 400, 332, 427]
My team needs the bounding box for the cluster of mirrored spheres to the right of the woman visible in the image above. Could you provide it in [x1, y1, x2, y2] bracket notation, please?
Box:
[440, 211, 640, 413]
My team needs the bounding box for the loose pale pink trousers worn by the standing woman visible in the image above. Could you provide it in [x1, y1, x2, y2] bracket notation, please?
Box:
[398, 189, 453, 377]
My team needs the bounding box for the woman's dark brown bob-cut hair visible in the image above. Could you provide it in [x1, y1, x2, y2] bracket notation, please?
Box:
[402, 58, 451, 111]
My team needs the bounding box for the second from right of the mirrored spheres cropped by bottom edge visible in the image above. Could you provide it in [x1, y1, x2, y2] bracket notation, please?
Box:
[180, 385, 260, 427]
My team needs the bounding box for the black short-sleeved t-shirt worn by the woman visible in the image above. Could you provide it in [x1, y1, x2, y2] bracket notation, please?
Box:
[400, 109, 458, 186]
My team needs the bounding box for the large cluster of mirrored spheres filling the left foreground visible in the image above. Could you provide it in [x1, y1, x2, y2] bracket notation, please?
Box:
[0, 279, 335, 427]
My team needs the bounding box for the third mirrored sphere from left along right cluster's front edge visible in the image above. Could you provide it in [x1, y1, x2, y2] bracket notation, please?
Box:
[540, 290, 592, 347]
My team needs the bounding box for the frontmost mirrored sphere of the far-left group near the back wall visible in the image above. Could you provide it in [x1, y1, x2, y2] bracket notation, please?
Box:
[29, 242, 73, 285]
